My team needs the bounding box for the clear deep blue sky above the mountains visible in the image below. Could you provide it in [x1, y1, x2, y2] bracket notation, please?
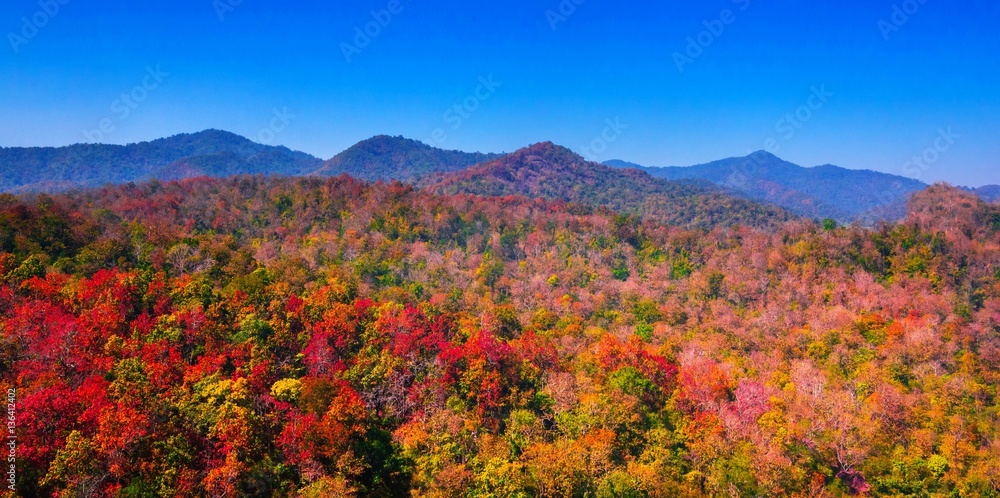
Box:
[0, 0, 1000, 186]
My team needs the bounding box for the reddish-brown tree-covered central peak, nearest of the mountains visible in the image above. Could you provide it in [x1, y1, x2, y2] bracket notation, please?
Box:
[423, 142, 792, 228]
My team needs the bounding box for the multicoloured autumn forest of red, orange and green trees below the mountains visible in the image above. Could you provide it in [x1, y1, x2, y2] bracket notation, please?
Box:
[0, 177, 1000, 497]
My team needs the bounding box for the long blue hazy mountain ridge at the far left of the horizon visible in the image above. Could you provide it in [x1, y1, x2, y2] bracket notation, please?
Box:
[0, 130, 322, 192]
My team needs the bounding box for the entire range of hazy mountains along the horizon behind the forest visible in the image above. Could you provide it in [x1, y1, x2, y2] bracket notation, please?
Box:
[0, 130, 1000, 227]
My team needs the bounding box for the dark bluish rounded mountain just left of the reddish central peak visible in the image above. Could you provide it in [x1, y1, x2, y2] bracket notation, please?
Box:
[316, 135, 499, 182]
